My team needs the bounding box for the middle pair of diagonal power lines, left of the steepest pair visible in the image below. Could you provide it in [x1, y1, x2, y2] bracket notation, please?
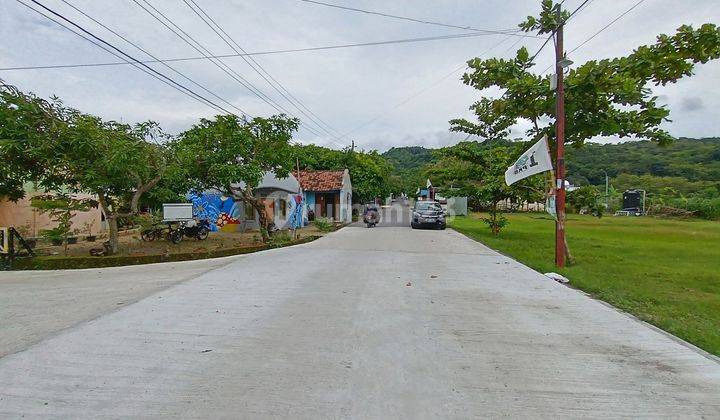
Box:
[133, 0, 322, 141]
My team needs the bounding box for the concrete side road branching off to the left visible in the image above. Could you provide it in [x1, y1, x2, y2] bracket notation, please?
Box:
[0, 257, 238, 357]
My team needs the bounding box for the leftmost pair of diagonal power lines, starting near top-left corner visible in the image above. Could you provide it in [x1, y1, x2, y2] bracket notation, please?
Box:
[16, 0, 232, 114]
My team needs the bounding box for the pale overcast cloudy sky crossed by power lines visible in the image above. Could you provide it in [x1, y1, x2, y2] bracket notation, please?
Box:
[0, 0, 720, 150]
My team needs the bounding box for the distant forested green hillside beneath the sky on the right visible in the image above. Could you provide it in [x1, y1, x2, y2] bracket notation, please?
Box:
[383, 138, 720, 219]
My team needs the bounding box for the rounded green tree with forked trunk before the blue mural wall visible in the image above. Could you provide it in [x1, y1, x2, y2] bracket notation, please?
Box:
[171, 115, 299, 242]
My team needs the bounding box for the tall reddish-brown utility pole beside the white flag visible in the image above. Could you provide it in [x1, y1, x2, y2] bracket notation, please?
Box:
[555, 5, 566, 268]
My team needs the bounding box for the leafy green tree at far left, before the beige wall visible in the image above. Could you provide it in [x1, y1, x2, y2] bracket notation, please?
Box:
[0, 85, 167, 253]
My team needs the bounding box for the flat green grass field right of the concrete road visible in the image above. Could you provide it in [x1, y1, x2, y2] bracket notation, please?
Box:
[450, 214, 720, 355]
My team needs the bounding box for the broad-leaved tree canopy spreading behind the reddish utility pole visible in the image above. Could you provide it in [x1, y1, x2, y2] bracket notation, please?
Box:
[450, 0, 720, 145]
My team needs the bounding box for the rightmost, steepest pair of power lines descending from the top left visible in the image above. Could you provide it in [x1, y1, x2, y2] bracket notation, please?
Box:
[183, 0, 337, 144]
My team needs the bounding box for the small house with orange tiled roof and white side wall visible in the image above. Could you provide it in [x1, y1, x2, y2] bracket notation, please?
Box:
[295, 169, 352, 223]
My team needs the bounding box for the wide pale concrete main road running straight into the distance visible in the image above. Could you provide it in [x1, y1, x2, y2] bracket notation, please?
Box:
[0, 227, 720, 419]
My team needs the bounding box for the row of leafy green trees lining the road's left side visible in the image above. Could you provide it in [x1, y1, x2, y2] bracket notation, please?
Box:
[0, 83, 392, 262]
